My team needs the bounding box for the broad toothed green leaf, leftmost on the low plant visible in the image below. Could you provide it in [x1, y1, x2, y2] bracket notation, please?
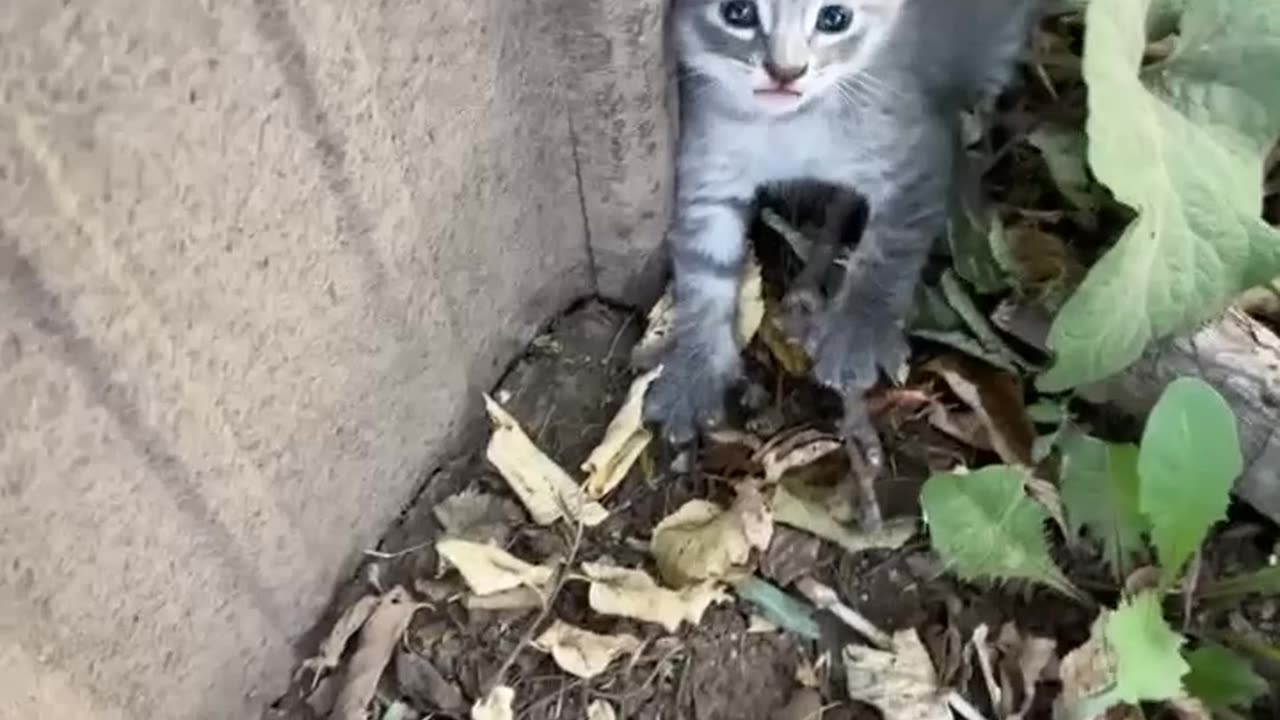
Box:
[920, 465, 1083, 600]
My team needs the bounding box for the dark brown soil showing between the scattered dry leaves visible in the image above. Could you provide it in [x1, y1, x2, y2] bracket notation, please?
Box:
[269, 286, 1280, 720]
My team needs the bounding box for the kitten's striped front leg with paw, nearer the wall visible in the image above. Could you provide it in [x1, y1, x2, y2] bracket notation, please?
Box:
[645, 196, 750, 445]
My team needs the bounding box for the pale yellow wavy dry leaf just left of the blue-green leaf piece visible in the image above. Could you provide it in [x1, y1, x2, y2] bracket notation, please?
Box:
[582, 562, 730, 633]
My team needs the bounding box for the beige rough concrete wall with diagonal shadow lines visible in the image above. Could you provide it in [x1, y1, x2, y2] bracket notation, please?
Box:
[0, 0, 669, 720]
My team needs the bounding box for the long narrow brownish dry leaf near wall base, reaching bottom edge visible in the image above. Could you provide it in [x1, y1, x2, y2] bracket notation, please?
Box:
[329, 585, 425, 720]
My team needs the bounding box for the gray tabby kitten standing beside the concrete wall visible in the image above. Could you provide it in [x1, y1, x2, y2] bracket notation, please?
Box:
[645, 0, 1038, 445]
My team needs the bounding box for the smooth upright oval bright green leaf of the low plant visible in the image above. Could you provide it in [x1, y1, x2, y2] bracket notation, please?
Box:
[1138, 378, 1244, 582]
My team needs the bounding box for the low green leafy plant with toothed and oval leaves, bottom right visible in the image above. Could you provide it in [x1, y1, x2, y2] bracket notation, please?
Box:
[922, 378, 1276, 708]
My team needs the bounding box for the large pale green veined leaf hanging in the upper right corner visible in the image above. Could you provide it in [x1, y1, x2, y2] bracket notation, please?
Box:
[1038, 0, 1280, 391]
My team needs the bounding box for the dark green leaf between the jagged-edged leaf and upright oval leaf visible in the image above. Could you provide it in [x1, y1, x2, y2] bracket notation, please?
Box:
[1059, 433, 1148, 577]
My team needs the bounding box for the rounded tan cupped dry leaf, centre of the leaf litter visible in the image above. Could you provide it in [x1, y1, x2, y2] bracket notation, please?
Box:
[650, 484, 773, 588]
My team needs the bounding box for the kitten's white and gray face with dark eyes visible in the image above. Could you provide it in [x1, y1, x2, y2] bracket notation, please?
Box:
[672, 0, 904, 115]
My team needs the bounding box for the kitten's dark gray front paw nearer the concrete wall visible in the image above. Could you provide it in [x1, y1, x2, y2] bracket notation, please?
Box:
[644, 347, 739, 447]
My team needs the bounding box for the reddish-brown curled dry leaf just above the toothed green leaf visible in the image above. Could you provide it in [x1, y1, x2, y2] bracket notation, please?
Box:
[924, 355, 1036, 466]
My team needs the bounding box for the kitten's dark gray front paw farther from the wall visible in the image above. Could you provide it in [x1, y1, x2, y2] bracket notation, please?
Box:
[805, 307, 910, 397]
